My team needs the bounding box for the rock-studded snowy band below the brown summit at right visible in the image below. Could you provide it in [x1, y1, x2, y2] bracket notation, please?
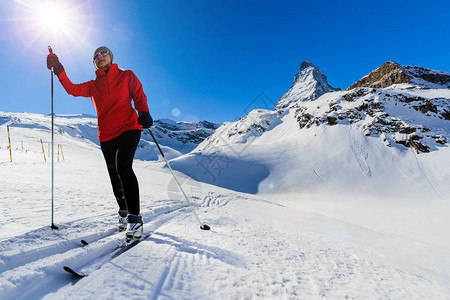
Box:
[295, 87, 450, 153]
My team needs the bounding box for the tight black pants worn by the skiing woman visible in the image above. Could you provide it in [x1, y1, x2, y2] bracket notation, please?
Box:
[100, 130, 141, 215]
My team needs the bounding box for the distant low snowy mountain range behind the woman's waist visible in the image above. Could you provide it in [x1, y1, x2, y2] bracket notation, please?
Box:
[0, 112, 219, 160]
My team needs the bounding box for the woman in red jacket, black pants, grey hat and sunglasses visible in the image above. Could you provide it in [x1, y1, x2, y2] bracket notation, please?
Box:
[47, 46, 153, 239]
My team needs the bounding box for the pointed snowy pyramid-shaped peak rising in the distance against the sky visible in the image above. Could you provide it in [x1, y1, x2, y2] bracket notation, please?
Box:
[275, 60, 340, 109]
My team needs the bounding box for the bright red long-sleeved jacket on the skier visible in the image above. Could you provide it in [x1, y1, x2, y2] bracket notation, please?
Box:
[59, 64, 149, 142]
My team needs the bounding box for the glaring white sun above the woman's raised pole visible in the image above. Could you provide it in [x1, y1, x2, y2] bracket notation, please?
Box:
[14, 0, 93, 54]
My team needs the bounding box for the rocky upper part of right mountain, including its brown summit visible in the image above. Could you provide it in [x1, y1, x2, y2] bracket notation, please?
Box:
[295, 62, 450, 153]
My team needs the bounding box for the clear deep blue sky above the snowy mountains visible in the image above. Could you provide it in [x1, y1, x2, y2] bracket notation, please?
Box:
[0, 0, 450, 122]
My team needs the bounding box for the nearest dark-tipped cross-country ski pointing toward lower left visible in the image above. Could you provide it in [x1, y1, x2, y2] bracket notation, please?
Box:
[63, 234, 150, 278]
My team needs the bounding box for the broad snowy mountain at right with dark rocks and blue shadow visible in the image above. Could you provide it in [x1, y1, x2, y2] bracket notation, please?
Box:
[172, 62, 450, 198]
